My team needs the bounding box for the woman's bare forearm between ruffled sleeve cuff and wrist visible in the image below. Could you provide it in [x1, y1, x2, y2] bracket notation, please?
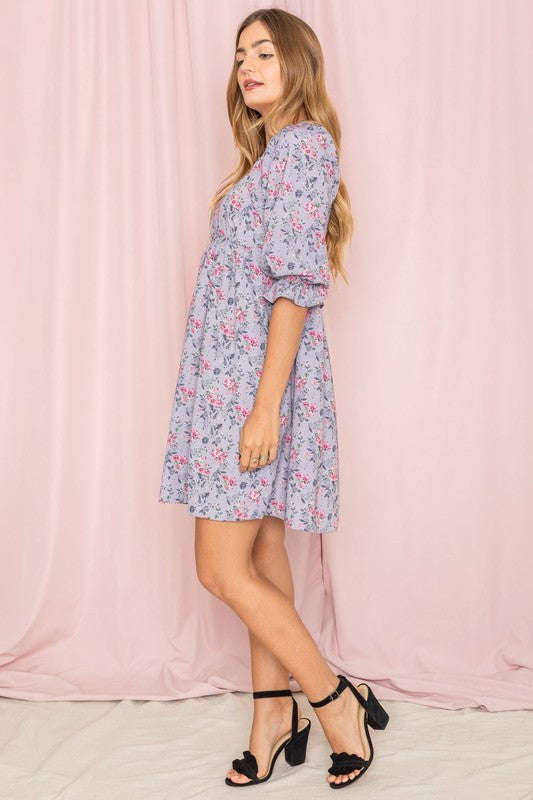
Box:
[255, 297, 308, 413]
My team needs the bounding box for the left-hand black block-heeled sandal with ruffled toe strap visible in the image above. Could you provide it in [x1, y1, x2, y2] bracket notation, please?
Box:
[225, 689, 311, 786]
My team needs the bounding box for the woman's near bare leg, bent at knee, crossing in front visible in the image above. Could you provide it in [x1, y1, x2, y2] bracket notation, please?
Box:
[195, 517, 363, 783]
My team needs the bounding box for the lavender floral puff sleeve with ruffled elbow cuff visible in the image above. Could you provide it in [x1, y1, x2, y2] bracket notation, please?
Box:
[261, 123, 339, 307]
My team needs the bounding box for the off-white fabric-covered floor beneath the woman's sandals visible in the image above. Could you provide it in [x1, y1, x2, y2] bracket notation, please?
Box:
[0, 692, 533, 800]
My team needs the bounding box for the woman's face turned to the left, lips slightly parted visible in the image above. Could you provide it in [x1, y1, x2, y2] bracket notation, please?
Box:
[235, 20, 282, 116]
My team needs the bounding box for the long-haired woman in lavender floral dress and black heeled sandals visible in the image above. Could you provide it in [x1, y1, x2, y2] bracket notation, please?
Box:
[160, 8, 388, 789]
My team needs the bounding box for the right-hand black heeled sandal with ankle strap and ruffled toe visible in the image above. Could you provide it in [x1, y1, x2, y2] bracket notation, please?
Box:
[309, 675, 389, 789]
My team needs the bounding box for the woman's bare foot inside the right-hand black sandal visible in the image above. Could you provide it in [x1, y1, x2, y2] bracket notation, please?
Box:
[313, 686, 366, 783]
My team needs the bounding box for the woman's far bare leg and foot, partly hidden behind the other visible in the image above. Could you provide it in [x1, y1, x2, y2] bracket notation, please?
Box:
[228, 516, 294, 783]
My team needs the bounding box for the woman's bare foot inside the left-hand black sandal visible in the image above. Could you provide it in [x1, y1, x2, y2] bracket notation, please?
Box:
[227, 695, 300, 783]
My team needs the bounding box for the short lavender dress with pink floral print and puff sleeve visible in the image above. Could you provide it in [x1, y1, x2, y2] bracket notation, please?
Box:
[159, 121, 340, 533]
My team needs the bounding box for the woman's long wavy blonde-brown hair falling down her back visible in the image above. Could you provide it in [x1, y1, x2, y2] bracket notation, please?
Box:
[209, 8, 354, 283]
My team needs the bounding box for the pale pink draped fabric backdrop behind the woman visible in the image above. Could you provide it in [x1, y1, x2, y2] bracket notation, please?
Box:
[0, 0, 533, 711]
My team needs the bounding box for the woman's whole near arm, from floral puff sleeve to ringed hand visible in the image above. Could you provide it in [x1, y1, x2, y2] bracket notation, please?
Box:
[239, 125, 339, 472]
